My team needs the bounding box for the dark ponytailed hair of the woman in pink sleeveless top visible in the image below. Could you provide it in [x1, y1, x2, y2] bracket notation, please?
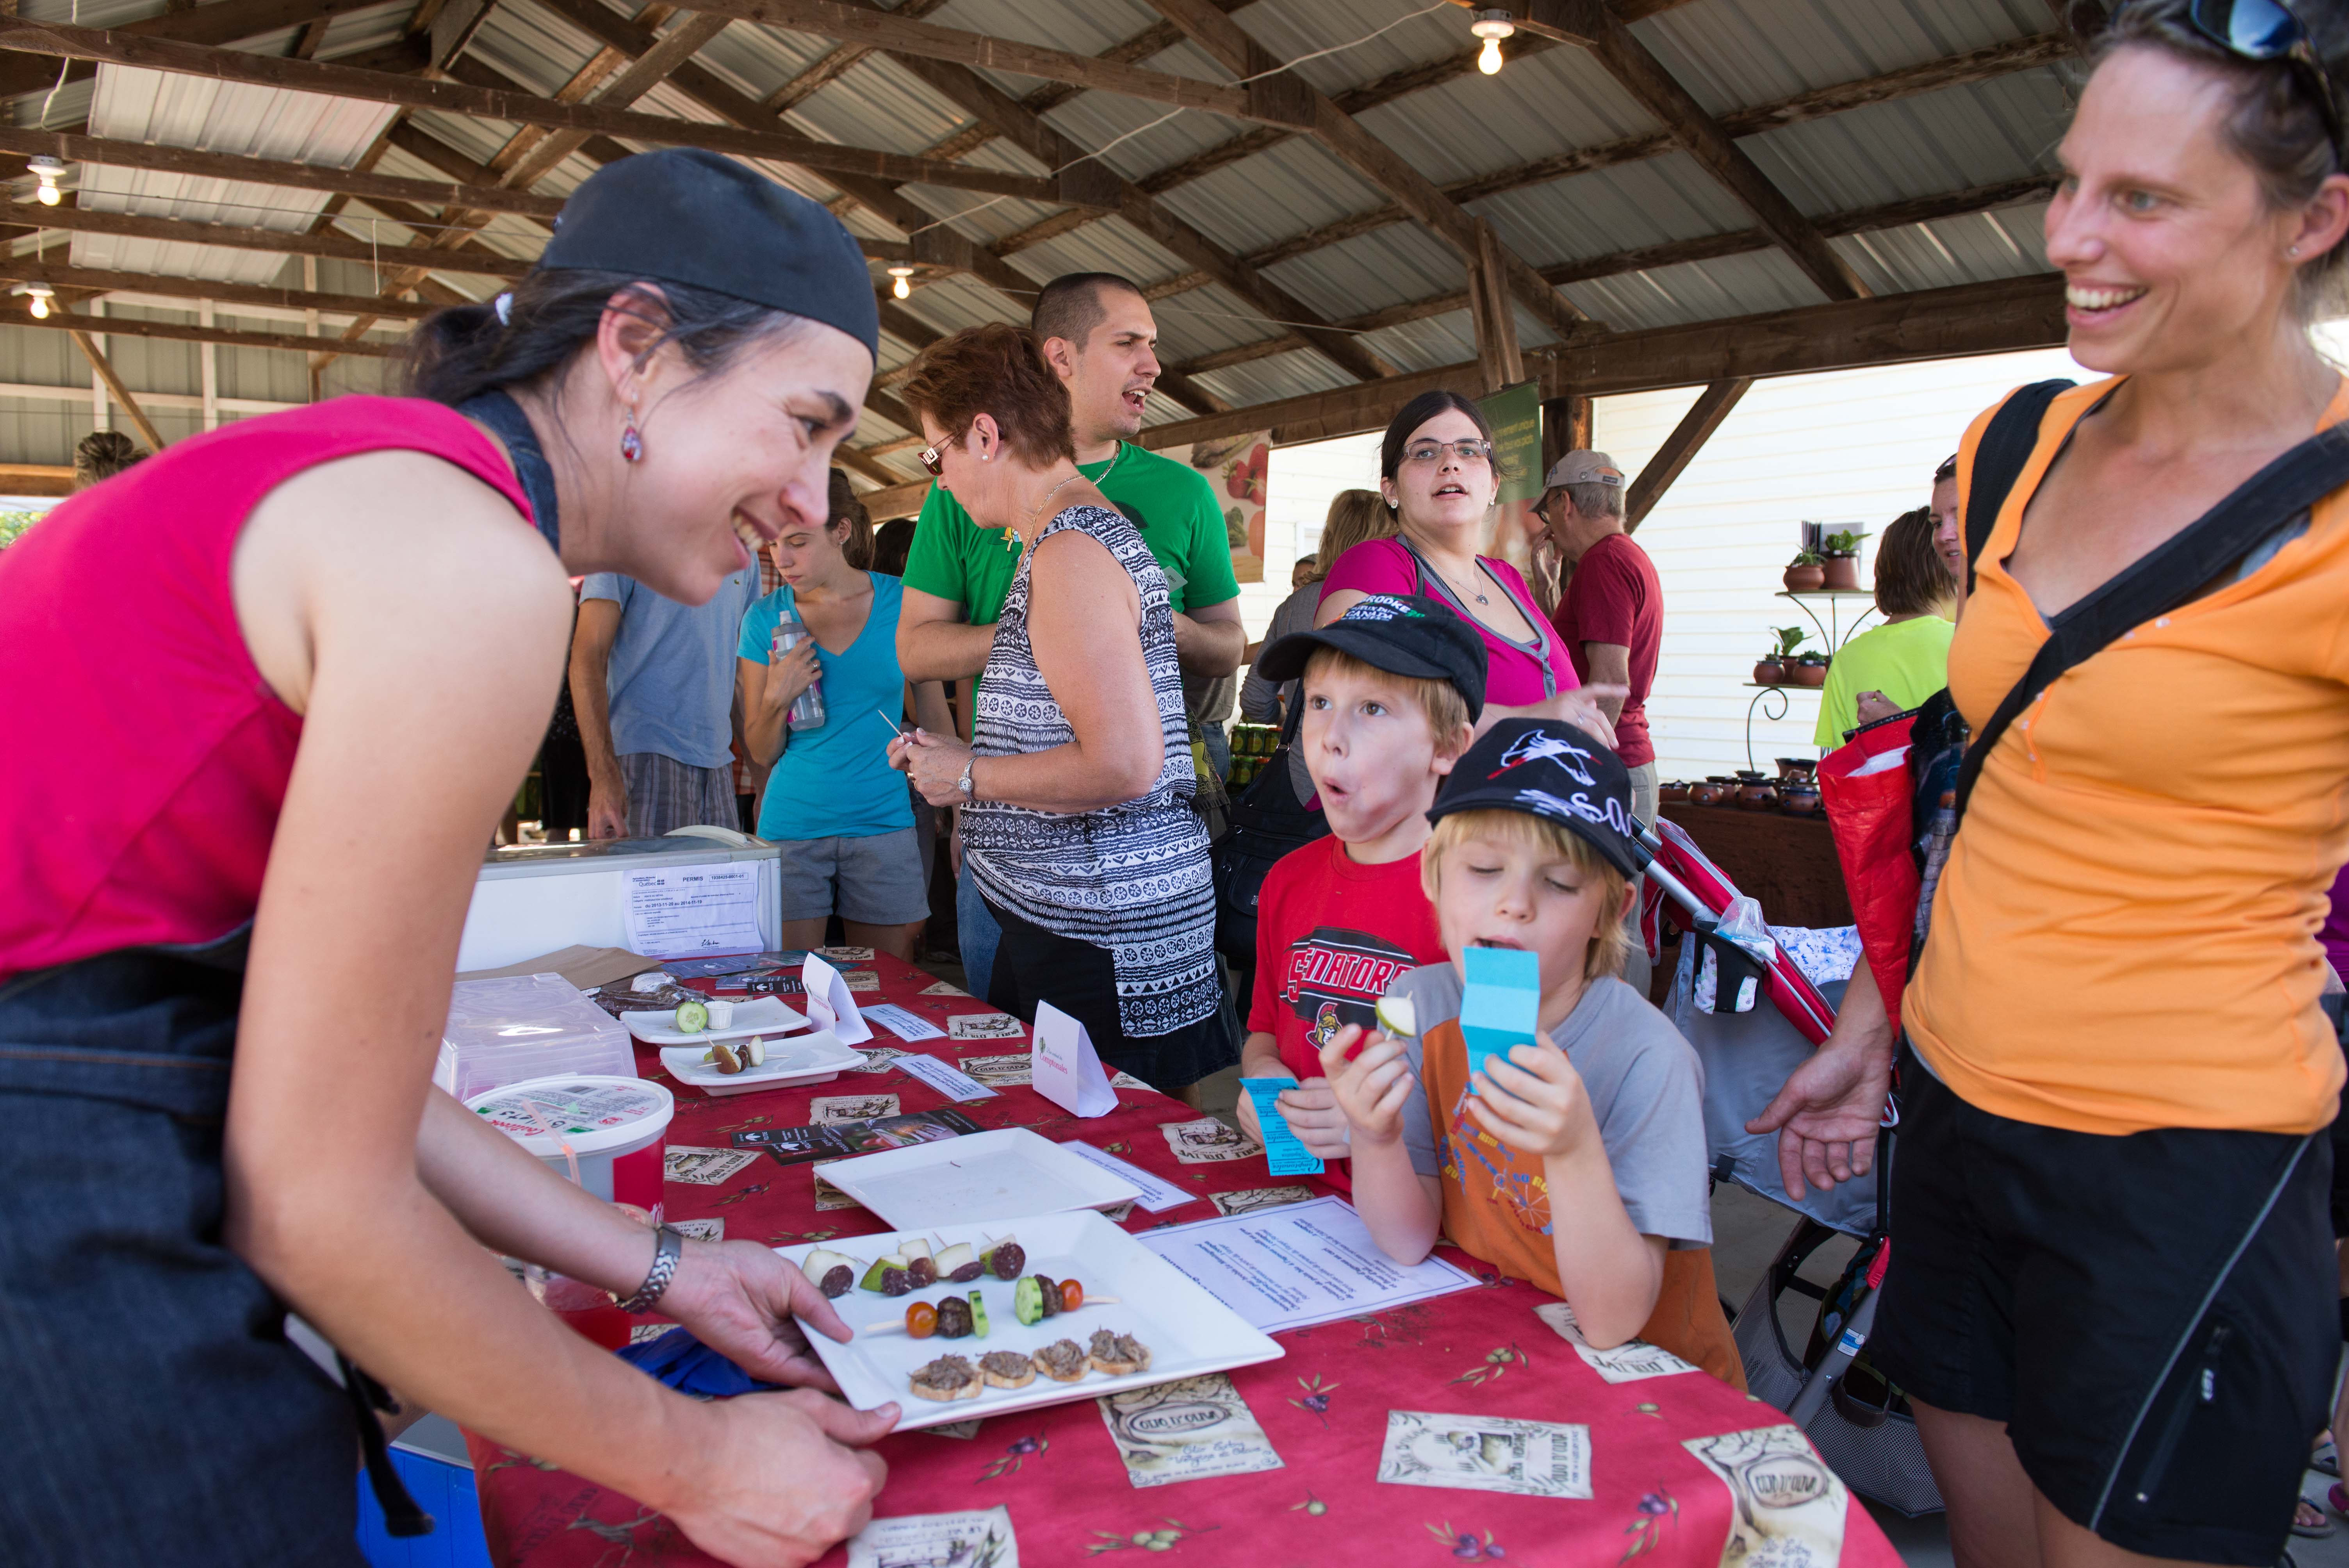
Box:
[406, 267, 806, 406]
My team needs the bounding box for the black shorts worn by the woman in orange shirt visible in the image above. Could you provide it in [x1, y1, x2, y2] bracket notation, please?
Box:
[1868, 1056, 2340, 1568]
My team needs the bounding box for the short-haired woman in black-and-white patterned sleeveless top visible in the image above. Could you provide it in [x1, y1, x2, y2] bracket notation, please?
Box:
[890, 324, 1238, 1094]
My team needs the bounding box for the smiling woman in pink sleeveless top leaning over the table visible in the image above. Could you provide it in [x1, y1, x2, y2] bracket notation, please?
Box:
[0, 153, 895, 1568]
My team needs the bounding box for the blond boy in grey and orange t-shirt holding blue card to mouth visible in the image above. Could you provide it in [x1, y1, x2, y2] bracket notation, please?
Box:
[1320, 718, 1743, 1385]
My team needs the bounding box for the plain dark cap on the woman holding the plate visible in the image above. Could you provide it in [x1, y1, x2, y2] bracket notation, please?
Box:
[538, 148, 881, 362]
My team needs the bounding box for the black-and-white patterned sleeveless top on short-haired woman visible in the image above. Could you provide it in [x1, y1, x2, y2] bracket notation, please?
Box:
[963, 507, 1217, 1037]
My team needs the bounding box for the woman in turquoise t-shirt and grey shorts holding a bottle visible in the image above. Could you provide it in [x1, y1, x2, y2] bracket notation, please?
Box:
[735, 469, 951, 962]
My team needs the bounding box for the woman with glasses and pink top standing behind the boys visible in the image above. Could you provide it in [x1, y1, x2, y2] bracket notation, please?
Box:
[1313, 392, 1614, 742]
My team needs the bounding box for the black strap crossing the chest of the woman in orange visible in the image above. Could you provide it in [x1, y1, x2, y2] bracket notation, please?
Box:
[1957, 425, 2349, 814]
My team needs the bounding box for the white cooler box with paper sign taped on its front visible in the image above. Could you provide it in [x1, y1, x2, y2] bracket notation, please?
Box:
[456, 829, 782, 974]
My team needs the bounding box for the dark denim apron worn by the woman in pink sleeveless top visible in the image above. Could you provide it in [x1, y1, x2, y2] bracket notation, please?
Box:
[0, 392, 554, 1568]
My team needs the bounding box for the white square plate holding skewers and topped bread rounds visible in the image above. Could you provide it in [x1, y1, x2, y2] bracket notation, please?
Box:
[775, 1211, 1285, 1432]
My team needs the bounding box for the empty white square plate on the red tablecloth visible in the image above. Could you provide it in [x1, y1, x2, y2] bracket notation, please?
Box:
[825, 1127, 1142, 1239]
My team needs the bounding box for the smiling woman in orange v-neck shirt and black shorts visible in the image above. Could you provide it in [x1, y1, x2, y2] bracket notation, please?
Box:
[1755, 0, 2349, 1568]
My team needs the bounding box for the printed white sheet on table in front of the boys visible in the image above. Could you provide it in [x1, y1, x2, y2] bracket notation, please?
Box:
[1135, 1197, 1477, 1333]
